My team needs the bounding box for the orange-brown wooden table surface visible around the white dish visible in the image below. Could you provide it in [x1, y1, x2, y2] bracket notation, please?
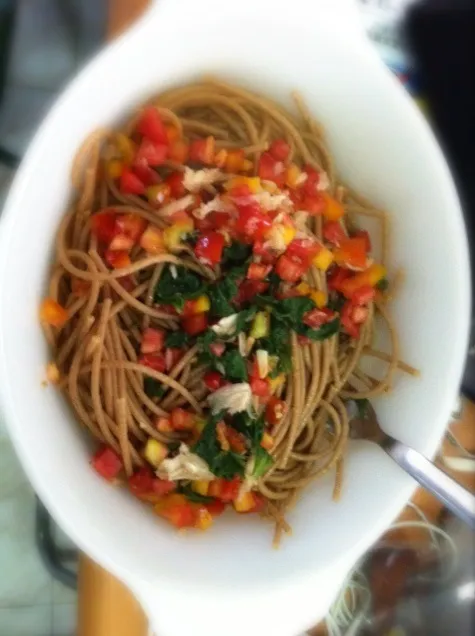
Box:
[78, 0, 475, 636]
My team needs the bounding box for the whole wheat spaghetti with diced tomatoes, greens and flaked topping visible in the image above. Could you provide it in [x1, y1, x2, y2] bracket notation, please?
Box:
[41, 79, 415, 543]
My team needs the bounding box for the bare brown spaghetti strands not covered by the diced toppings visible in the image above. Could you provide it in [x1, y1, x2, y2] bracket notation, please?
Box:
[46, 79, 416, 542]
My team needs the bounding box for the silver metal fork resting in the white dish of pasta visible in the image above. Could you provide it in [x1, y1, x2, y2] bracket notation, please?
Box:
[350, 403, 475, 530]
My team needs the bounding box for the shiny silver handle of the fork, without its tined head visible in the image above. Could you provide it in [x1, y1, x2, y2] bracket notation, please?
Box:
[382, 435, 475, 530]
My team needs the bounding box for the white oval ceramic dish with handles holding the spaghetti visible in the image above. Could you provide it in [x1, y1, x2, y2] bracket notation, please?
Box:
[0, 0, 469, 636]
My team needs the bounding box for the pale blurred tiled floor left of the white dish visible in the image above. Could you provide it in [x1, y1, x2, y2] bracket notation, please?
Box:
[0, 0, 105, 636]
